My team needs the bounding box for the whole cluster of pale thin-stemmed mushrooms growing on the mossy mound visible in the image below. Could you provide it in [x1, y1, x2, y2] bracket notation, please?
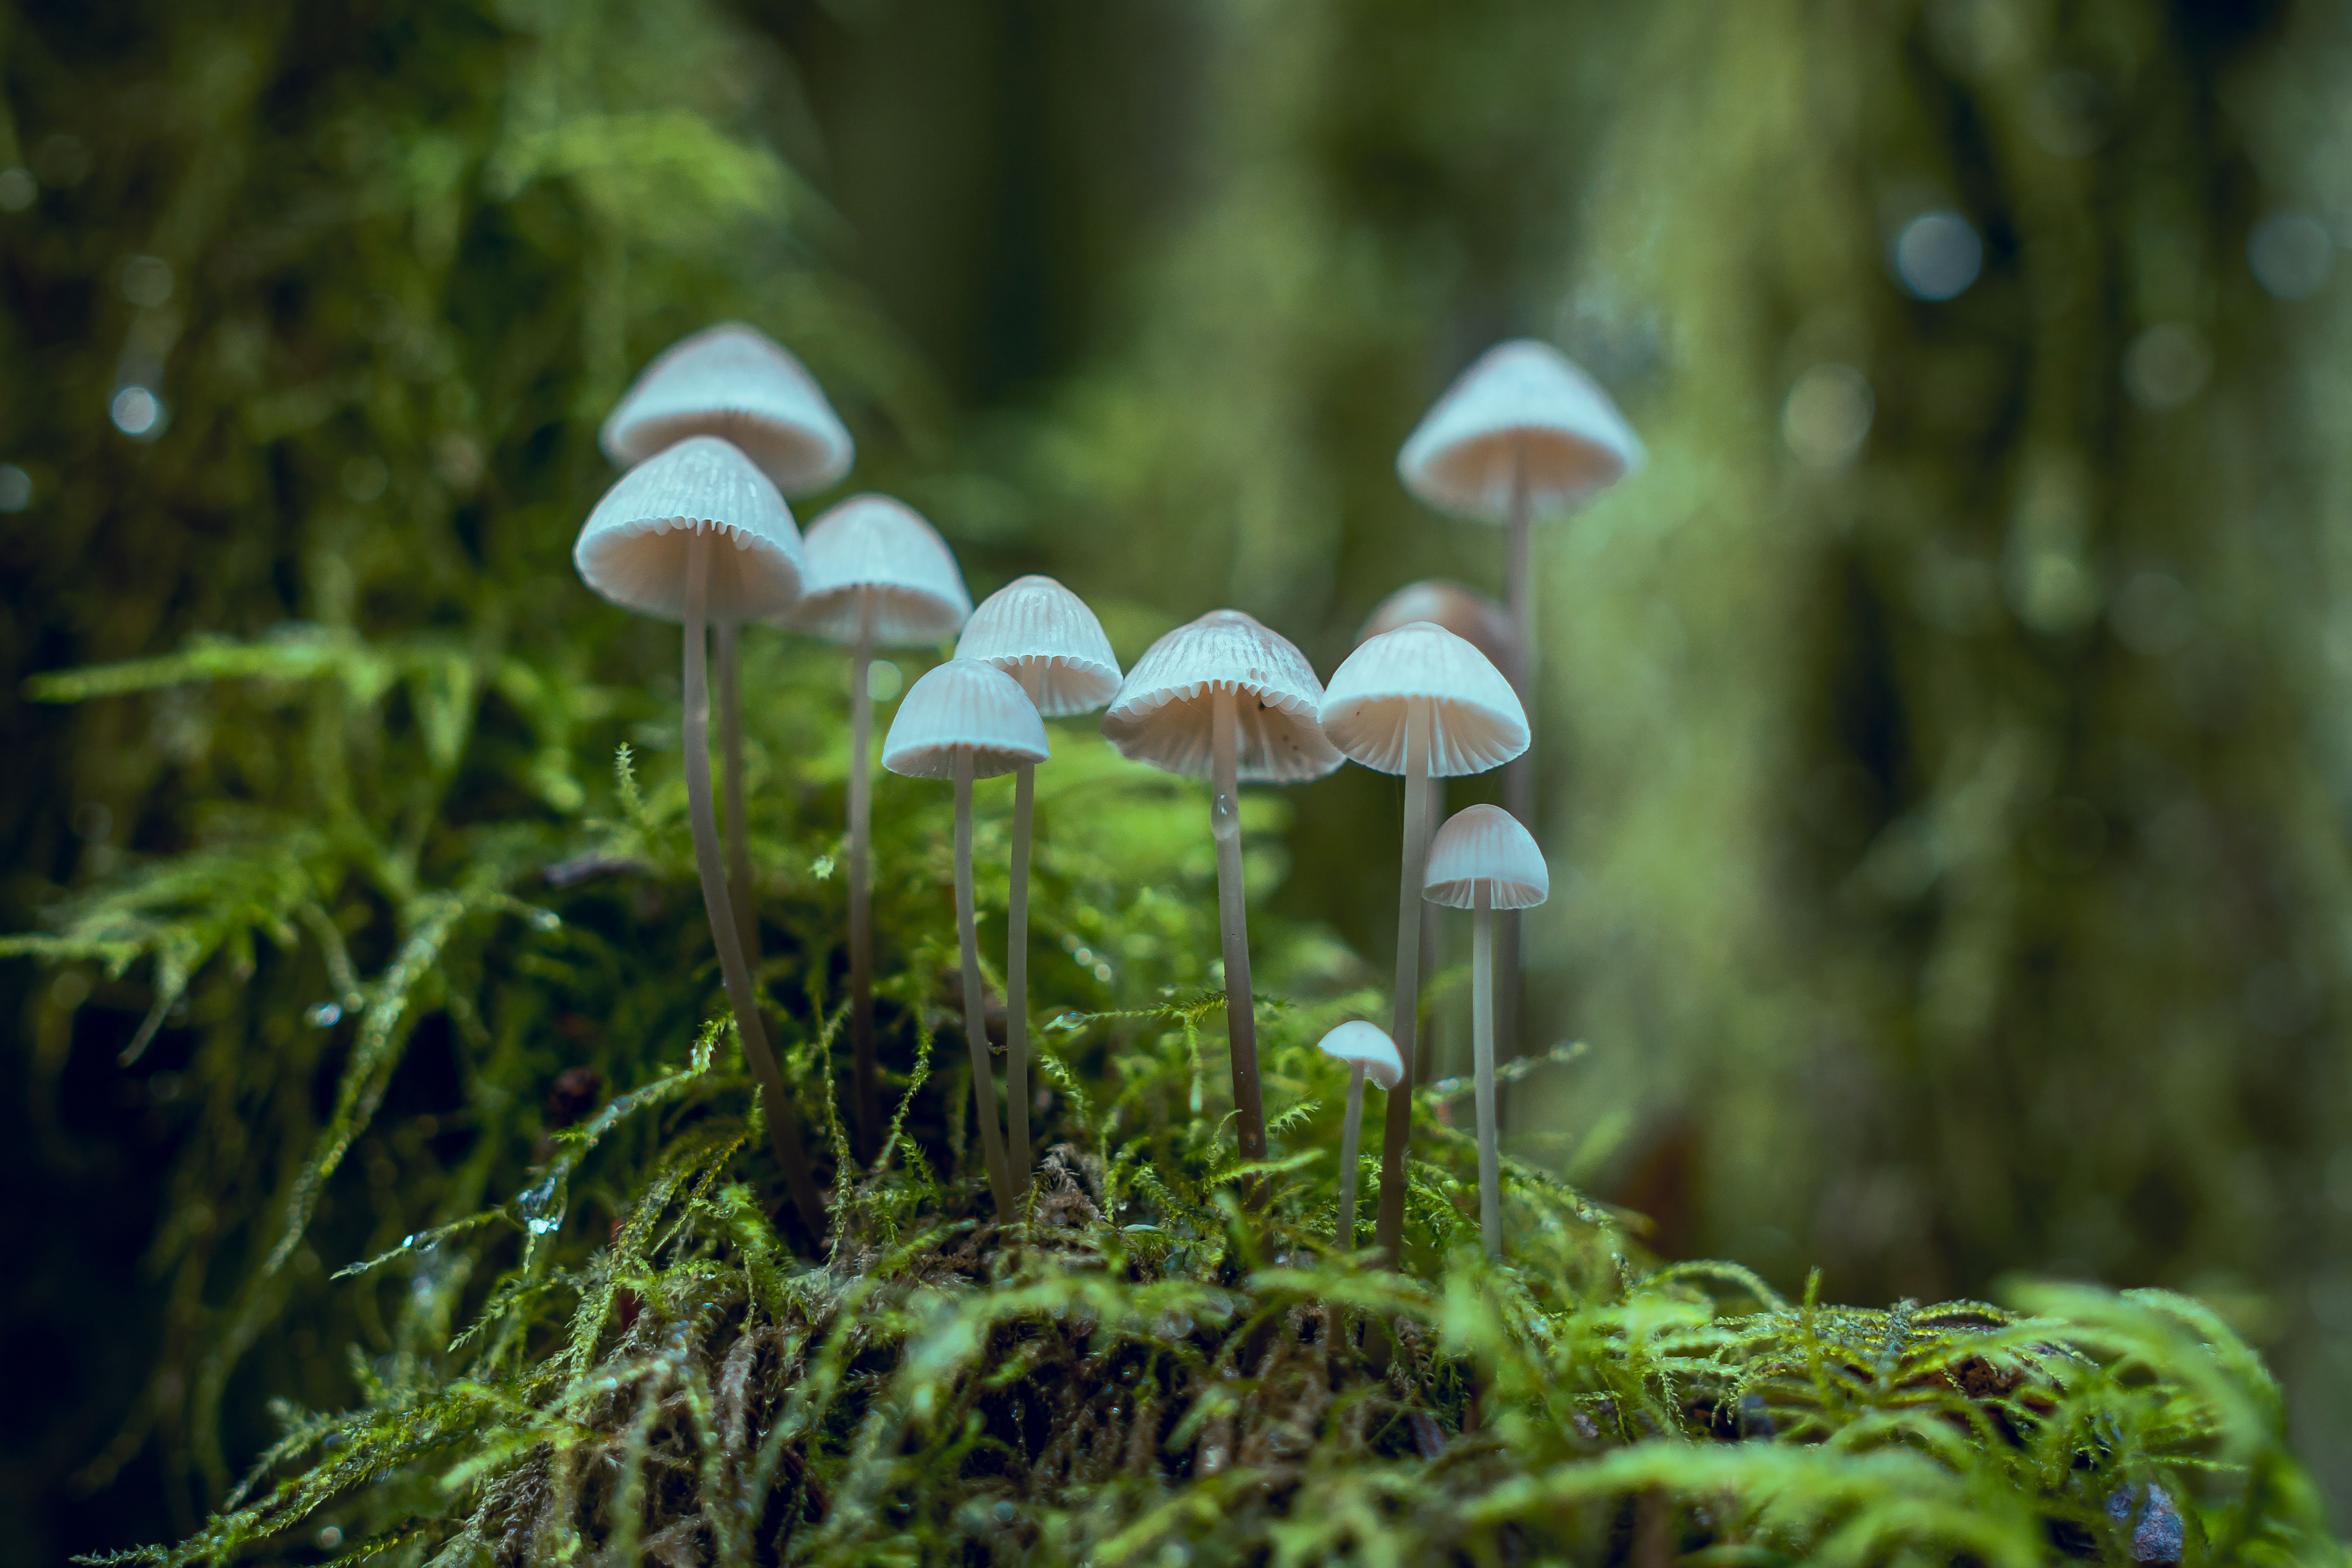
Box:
[574, 325, 1642, 1260]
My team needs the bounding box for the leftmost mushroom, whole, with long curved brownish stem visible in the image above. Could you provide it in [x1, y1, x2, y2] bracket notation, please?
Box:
[572, 435, 826, 1239]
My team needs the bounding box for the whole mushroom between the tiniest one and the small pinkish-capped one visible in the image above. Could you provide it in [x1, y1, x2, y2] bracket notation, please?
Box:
[1322, 621, 1526, 1262]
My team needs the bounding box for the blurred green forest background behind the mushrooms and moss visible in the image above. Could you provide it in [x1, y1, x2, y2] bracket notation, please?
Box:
[0, 0, 2352, 1563]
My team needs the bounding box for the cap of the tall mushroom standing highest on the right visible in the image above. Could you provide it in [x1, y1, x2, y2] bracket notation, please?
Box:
[1397, 339, 1642, 522]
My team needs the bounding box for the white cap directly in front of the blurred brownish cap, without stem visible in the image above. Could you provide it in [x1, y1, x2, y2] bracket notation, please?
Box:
[1322, 621, 1529, 778]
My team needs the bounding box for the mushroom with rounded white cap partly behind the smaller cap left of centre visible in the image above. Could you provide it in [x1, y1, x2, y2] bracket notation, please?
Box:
[955, 576, 1120, 1180]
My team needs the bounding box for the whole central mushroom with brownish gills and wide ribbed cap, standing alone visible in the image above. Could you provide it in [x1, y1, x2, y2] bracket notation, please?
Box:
[1103, 609, 1341, 1161]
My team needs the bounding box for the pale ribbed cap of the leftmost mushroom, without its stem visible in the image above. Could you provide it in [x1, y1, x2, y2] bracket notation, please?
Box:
[572, 435, 802, 621]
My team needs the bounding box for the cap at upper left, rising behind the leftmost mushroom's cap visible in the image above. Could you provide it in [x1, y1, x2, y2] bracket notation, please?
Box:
[597, 322, 856, 496]
